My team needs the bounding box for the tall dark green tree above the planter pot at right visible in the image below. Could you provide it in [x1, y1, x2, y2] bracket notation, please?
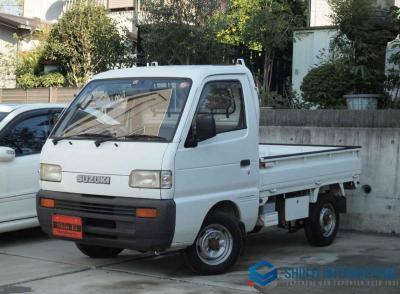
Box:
[329, 0, 396, 94]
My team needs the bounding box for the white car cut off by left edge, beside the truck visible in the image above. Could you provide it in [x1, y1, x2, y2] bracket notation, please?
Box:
[0, 104, 63, 233]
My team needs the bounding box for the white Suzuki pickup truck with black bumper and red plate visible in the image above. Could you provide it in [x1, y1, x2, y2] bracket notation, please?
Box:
[37, 64, 361, 274]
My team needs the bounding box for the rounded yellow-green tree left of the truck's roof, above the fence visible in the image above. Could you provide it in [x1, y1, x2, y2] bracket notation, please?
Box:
[44, 0, 135, 86]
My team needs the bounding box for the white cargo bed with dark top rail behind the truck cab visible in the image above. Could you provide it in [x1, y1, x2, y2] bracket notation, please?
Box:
[259, 144, 361, 198]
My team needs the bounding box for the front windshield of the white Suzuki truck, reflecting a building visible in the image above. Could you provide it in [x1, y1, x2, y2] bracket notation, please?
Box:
[52, 78, 191, 142]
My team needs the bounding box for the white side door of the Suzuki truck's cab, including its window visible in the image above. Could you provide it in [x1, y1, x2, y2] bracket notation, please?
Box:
[174, 75, 258, 243]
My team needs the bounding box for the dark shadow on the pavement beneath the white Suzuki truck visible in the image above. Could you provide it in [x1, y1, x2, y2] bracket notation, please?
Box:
[104, 230, 315, 285]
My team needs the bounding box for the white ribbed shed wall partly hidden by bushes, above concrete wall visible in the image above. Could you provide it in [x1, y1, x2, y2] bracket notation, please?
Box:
[292, 28, 336, 94]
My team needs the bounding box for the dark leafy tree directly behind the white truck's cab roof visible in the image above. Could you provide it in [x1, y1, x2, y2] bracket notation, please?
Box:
[139, 0, 230, 64]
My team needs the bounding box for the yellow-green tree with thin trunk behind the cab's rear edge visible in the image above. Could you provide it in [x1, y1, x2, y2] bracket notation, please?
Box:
[218, 0, 305, 100]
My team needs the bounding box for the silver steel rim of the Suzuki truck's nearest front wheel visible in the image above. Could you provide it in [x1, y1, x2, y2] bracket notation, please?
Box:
[196, 225, 233, 265]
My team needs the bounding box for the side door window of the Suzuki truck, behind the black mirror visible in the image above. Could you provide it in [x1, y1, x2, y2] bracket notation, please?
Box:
[197, 81, 246, 134]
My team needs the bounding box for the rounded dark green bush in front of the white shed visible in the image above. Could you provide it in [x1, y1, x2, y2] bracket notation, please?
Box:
[300, 62, 352, 108]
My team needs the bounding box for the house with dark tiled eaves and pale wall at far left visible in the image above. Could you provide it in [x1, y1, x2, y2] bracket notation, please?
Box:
[0, 13, 41, 88]
